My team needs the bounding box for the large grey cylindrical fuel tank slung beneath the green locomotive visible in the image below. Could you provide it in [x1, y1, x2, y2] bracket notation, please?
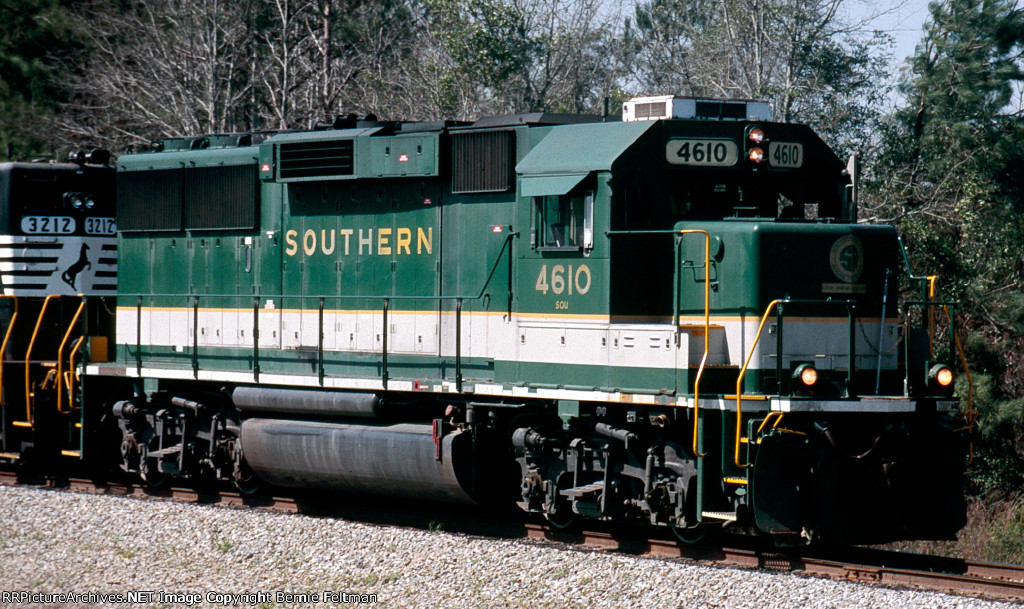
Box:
[242, 419, 475, 504]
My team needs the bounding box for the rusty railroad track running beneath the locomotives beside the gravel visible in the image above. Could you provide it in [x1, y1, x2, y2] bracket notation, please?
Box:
[0, 470, 1024, 602]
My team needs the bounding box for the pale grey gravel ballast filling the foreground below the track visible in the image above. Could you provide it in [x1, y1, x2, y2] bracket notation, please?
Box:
[0, 486, 1016, 609]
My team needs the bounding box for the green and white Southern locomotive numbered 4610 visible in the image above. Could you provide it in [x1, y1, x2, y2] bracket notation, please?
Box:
[54, 97, 969, 545]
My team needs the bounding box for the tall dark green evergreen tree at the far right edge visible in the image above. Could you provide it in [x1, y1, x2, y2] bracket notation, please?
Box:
[864, 0, 1024, 495]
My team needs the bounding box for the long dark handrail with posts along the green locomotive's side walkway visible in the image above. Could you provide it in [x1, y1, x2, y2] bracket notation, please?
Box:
[118, 232, 519, 392]
